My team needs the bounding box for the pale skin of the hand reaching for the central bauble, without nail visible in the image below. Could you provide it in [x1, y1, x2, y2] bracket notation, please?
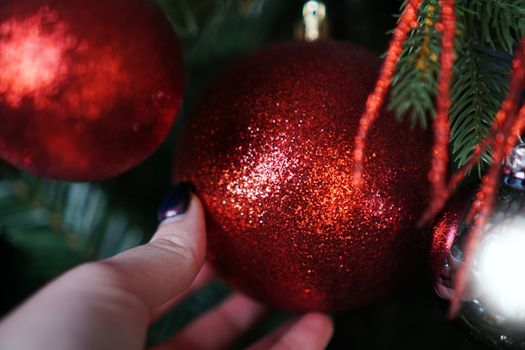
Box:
[0, 196, 333, 350]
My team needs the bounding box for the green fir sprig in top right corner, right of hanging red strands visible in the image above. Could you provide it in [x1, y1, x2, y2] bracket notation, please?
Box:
[450, 0, 521, 175]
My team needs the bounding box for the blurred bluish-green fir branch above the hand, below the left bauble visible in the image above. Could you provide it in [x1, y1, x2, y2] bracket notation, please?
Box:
[0, 174, 143, 282]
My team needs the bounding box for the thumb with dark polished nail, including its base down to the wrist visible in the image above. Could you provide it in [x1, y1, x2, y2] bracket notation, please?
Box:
[0, 185, 206, 349]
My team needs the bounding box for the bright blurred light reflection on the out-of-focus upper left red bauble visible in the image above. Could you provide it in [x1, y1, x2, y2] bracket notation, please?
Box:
[0, 6, 131, 120]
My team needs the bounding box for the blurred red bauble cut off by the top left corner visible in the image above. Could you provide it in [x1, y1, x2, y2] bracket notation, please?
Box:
[0, 0, 183, 180]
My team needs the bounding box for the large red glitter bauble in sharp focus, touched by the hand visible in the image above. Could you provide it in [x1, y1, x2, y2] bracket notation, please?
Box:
[175, 41, 432, 311]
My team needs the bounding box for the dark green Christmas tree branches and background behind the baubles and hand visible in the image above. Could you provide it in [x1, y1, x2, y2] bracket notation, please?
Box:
[0, 0, 525, 349]
